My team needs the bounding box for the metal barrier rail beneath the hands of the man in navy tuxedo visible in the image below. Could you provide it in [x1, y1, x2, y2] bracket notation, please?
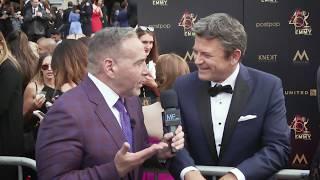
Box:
[196, 166, 310, 179]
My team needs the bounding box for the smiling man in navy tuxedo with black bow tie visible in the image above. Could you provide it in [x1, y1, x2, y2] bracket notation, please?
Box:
[170, 13, 290, 180]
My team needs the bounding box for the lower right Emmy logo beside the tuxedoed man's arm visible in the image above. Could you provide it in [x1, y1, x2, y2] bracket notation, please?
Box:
[290, 114, 311, 141]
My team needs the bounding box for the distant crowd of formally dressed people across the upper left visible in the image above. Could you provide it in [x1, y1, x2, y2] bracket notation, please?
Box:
[0, 0, 137, 42]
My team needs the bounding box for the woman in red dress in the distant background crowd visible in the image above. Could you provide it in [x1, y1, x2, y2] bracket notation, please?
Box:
[91, 0, 103, 33]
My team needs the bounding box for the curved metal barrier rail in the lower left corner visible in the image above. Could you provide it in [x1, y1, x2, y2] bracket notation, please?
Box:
[0, 156, 37, 180]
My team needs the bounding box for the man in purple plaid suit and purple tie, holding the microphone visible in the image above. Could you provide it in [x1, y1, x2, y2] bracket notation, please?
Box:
[36, 28, 184, 180]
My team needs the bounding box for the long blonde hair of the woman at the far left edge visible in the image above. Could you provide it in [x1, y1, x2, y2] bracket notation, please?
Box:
[0, 31, 21, 72]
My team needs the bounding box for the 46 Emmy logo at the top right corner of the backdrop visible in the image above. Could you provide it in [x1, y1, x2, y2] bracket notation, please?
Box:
[289, 9, 312, 36]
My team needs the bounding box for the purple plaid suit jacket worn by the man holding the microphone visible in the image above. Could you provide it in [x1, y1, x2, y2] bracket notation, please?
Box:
[36, 77, 148, 180]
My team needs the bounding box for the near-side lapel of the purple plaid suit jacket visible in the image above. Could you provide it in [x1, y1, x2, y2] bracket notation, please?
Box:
[82, 77, 125, 149]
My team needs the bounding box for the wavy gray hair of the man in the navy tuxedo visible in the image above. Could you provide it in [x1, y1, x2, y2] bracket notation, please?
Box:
[192, 13, 247, 57]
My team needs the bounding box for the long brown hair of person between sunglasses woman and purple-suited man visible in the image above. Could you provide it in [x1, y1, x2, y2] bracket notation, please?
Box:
[51, 39, 88, 93]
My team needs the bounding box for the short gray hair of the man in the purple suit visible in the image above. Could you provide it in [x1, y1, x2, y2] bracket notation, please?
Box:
[88, 27, 137, 74]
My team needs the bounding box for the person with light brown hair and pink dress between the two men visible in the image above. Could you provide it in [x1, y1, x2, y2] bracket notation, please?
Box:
[142, 53, 190, 180]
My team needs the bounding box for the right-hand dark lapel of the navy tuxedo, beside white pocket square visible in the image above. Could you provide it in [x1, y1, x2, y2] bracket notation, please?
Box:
[219, 65, 250, 162]
